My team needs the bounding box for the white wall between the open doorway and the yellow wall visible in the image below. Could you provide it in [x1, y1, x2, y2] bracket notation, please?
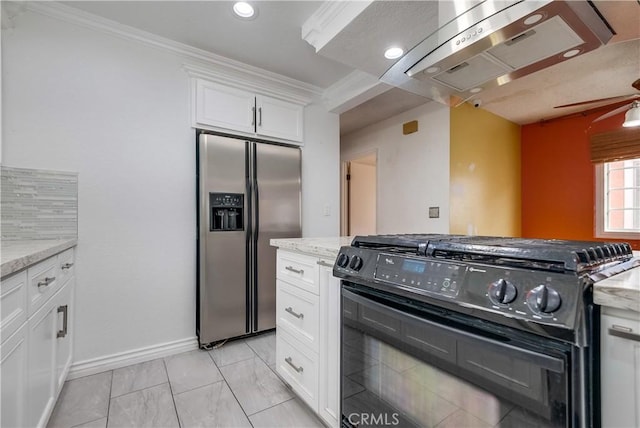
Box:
[340, 102, 449, 234]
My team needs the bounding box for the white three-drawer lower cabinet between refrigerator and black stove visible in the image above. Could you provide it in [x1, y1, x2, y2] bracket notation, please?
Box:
[276, 249, 340, 427]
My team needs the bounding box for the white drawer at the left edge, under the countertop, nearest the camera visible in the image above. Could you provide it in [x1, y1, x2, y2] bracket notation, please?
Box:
[0, 270, 27, 343]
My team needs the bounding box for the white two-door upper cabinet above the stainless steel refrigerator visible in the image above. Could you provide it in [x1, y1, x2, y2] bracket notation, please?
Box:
[194, 79, 304, 143]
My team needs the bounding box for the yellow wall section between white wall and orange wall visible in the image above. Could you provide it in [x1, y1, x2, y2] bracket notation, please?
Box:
[449, 103, 521, 236]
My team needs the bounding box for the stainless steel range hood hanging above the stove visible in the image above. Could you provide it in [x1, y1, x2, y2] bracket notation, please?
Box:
[381, 0, 614, 105]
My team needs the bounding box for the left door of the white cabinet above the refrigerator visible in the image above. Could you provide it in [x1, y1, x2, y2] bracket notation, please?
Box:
[195, 79, 255, 133]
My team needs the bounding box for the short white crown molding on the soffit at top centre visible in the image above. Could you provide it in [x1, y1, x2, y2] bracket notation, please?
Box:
[302, 0, 373, 52]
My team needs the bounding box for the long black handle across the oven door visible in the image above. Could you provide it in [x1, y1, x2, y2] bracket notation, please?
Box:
[342, 285, 565, 373]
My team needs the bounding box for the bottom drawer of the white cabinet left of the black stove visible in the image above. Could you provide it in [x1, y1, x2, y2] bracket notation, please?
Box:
[276, 328, 318, 413]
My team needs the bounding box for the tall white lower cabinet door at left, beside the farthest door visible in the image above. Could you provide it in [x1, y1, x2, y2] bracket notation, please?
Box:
[27, 298, 58, 427]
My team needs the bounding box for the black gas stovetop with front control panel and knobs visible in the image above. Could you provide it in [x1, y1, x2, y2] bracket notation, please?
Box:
[334, 234, 638, 342]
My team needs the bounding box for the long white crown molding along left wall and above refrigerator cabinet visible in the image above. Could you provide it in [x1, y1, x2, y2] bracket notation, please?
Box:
[26, 2, 323, 104]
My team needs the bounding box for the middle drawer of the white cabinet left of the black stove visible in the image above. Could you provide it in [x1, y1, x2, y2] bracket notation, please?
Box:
[276, 281, 320, 352]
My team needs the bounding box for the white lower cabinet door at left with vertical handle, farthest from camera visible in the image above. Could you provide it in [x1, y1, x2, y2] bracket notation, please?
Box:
[54, 277, 76, 396]
